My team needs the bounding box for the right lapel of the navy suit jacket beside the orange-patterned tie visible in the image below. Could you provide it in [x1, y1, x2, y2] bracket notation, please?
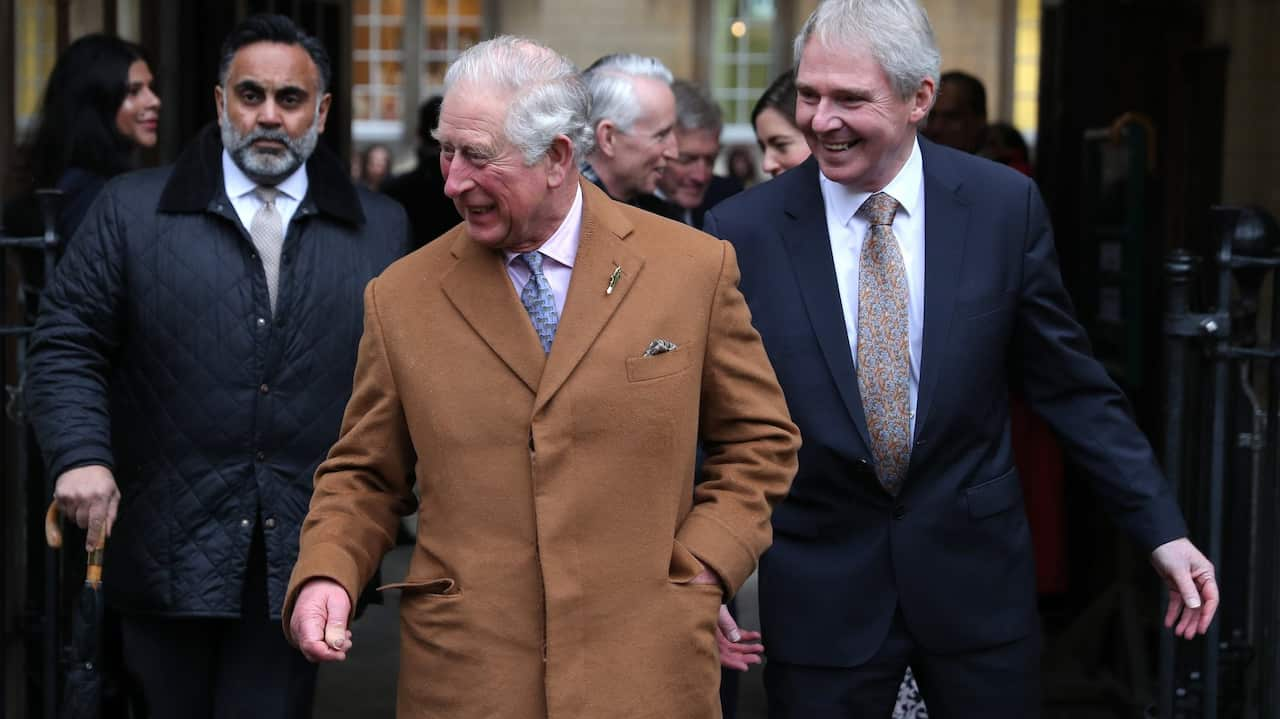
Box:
[915, 138, 969, 436]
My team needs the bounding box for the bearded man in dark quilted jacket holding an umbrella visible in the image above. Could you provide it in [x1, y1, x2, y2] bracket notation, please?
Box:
[27, 15, 408, 716]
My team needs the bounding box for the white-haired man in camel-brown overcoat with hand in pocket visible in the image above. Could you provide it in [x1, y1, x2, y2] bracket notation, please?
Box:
[285, 37, 799, 719]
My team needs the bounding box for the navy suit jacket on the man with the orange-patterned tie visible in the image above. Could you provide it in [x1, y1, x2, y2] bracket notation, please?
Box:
[705, 138, 1187, 667]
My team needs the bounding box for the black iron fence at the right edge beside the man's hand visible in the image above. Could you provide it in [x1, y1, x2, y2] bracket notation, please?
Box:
[1158, 207, 1280, 719]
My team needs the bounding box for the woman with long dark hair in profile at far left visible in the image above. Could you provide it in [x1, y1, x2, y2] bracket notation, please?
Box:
[5, 35, 160, 242]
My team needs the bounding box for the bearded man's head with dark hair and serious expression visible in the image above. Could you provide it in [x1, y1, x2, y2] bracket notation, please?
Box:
[214, 42, 330, 184]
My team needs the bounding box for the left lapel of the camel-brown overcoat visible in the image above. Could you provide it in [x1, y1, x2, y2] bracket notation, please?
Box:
[443, 232, 547, 391]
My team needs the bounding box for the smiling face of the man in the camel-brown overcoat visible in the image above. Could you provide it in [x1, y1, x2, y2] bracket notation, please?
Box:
[435, 86, 573, 252]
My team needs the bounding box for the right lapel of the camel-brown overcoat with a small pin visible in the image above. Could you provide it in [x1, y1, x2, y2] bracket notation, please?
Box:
[525, 183, 644, 412]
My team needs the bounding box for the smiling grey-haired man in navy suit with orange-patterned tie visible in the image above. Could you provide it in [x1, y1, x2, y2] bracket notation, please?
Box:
[705, 0, 1217, 719]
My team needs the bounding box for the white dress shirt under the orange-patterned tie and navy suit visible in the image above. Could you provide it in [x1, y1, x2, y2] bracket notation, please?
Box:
[818, 142, 924, 434]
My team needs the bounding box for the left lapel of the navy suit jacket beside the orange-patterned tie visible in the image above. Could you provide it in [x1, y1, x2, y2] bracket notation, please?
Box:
[774, 157, 872, 446]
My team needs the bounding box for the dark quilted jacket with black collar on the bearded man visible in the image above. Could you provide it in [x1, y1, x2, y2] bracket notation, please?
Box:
[27, 127, 408, 618]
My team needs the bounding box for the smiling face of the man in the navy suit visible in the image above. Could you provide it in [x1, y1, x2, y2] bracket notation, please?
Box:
[796, 40, 933, 192]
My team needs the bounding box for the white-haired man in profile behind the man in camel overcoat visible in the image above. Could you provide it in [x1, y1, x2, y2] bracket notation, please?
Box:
[582, 54, 678, 216]
